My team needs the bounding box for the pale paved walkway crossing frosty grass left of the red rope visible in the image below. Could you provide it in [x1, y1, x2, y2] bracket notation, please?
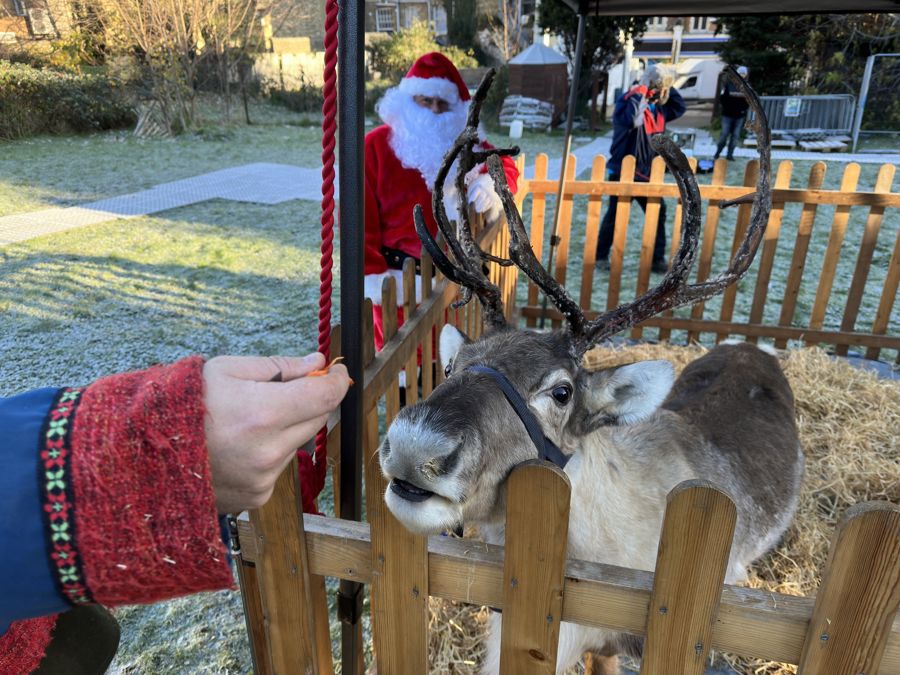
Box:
[0, 163, 330, 246]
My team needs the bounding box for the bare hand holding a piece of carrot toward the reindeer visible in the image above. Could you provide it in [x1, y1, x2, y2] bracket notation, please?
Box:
[203, 353, 350, 513]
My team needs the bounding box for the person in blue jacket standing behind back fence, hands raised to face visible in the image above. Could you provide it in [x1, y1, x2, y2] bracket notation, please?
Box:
[597, 65, 685, 273]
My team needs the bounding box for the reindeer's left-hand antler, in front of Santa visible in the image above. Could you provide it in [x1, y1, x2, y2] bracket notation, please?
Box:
[413, 68, 519, 328]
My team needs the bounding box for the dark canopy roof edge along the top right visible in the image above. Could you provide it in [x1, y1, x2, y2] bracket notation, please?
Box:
[562, 0, 900, 16]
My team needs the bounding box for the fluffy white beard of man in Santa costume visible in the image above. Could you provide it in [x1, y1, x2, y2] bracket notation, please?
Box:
[375, 87, 472, 190]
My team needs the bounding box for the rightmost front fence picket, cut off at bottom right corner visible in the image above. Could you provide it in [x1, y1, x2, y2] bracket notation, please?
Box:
[799, 502, 900, 675]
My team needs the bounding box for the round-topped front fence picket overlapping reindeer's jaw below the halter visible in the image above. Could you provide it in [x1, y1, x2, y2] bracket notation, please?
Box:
[500, 459, 570, 675]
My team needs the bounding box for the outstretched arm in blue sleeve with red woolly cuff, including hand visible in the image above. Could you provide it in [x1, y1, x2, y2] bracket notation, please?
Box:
[0, 354, 350, 675]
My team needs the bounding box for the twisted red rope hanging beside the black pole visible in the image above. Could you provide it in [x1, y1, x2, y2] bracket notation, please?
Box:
[298, 0, 338, 513]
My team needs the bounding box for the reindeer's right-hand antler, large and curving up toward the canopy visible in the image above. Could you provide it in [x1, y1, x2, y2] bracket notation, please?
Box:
[488, 66, 772, 358]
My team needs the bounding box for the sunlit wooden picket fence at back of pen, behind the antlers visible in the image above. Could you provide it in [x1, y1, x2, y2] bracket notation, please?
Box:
[519, 155, 900, 363]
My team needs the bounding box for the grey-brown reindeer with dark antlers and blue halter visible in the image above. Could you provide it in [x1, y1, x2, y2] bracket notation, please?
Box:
[379, 72, 803, 673]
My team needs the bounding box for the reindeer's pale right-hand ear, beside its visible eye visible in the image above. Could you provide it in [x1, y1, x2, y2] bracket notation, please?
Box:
[585, 361, 675, 426]
